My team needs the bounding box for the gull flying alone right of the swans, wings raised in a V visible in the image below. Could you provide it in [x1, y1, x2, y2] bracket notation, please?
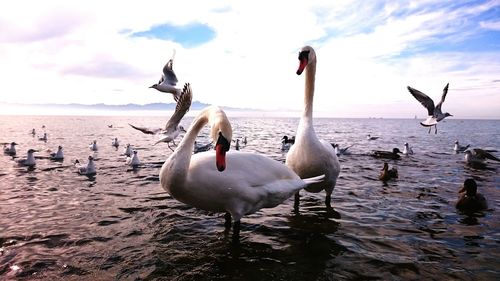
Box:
[407, 83, 453, 134]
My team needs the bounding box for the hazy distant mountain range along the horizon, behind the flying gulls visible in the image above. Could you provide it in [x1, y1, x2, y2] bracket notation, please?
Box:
[0, 101, 260, 111]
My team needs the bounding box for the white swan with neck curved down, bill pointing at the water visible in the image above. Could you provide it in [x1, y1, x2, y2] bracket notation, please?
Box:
[160, 103, 323, 237]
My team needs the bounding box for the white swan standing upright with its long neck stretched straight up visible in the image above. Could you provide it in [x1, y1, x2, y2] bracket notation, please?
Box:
[285, 46, 340, 210]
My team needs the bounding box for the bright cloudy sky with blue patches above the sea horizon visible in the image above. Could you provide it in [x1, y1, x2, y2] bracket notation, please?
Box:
[0, 0, 500, 118]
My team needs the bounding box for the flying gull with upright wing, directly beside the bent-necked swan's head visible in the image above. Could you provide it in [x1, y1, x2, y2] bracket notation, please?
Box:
[129, 83, 193, 151]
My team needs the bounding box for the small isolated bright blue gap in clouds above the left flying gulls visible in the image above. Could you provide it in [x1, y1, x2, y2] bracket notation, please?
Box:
[130, 23, 215, 48]
